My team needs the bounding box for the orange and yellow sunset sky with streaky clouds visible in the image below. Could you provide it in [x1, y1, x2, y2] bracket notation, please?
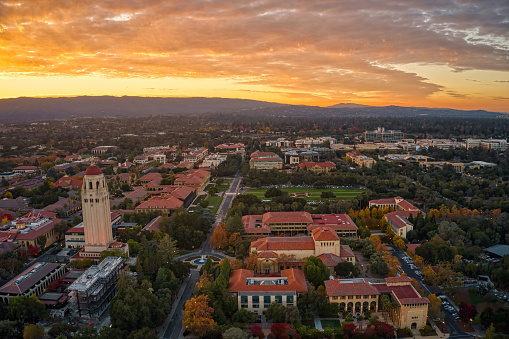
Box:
[0, 0, 509, 112]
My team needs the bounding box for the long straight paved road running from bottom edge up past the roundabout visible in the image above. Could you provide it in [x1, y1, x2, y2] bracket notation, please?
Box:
[159, 173, 242, 339]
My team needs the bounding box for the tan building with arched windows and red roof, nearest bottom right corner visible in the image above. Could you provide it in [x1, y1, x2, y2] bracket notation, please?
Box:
[325, 276, 429, 329]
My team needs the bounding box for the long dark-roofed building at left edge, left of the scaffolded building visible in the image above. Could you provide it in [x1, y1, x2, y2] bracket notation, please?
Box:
[0, 263, 66, 303]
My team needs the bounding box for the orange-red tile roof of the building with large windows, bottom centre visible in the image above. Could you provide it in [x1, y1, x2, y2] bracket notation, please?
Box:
[228, 268, 307, 292]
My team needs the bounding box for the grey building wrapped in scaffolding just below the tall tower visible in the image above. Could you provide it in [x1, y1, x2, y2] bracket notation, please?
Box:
[67, 257, 124, 319]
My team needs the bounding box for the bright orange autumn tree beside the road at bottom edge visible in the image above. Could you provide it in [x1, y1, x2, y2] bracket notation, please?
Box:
[182, 295, 217, 338]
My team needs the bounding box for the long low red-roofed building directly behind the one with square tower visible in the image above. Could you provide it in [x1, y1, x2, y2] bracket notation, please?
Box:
[242, 212, 358, 238]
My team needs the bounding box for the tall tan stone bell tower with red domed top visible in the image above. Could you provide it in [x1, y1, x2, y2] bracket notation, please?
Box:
[81, 165, 113, 253]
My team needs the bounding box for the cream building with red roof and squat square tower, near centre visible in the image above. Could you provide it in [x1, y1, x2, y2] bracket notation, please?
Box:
[249, 226, 355, 274]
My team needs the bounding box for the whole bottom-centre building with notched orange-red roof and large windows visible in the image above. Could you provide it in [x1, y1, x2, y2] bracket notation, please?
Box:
[228, 268, 307, 314]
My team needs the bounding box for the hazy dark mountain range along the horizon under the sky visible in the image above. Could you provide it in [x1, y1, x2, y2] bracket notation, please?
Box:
[0, 96, 502, 122]
